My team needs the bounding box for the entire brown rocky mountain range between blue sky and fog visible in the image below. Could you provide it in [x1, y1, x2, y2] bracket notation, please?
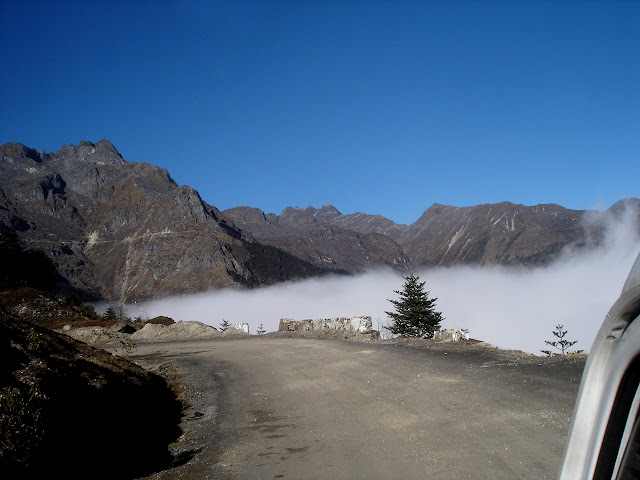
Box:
[0, 140, 640, 301]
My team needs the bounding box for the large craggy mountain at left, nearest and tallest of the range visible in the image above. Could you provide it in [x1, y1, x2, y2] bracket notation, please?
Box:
[0, 140, 322, 301]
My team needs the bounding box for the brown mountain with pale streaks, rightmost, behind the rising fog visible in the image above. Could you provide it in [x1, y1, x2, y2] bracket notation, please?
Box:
[398, 202, 587, 266]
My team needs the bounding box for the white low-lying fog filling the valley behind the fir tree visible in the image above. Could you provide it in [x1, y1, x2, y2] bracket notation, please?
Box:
[127, 212, 640, 354]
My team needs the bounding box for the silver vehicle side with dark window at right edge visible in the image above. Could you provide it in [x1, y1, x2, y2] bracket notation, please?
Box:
[558, 251, 640, 480]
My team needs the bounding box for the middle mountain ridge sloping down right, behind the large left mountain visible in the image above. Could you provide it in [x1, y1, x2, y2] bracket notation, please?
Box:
[223, 205, 408, 273]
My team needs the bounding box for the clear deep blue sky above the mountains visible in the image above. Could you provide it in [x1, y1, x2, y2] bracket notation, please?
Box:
[0, 0, 640, 223]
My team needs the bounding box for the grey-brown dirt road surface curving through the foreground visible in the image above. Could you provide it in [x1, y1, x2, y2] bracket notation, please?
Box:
[132, 336, 584, 480]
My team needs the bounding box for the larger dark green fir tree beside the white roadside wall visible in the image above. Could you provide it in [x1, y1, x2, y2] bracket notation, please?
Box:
[384, 273, 444, 338]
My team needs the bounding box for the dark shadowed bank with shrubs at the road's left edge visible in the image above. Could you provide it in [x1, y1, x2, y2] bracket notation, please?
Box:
[0, 308, 182, 479]
